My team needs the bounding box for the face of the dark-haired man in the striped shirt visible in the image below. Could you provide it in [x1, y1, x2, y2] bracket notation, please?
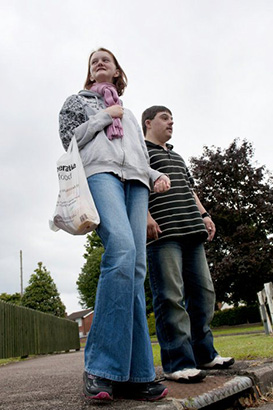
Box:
[149, 111, 173, 143]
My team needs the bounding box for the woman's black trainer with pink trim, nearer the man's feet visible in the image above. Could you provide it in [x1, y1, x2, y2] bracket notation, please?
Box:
[114, 382, 168, 401]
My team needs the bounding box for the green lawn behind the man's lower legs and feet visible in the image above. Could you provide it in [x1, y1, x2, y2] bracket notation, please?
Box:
[152, 326, 273, 366]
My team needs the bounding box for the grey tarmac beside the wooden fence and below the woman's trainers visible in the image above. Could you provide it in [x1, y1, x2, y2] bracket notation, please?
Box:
[0, 351, 176, 410]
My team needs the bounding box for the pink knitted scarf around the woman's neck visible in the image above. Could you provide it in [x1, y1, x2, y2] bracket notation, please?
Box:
[91, 83, 123, 140]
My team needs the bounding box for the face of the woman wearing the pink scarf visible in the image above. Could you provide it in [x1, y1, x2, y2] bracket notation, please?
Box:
[90, 51, 119, 83]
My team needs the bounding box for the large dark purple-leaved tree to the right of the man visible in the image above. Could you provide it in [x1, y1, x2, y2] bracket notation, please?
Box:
[190, 139, 273, 305]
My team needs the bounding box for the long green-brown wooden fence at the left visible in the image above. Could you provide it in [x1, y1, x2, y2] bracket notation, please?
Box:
[0, 301, 80, 359]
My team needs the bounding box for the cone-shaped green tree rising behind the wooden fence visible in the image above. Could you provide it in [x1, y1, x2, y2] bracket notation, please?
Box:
[22, 262, 65, 317]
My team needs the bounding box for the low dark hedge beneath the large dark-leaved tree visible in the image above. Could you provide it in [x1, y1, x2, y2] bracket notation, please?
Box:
[211, 305, 261, 327]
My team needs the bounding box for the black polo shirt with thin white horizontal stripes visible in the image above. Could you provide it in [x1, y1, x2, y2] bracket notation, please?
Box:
[146, 141, 207, 245]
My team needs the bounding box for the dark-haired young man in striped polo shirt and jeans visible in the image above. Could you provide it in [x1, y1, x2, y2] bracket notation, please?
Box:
[142, 106, 234, 383]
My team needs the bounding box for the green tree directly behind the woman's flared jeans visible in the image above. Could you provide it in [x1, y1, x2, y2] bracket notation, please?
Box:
[77, 232, 153, 313]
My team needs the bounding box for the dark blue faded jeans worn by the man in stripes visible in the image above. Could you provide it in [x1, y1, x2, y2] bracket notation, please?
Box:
[147, 239, 217, 373]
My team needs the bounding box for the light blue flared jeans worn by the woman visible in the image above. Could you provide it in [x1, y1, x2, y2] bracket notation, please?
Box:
[85, 173, 155, 382]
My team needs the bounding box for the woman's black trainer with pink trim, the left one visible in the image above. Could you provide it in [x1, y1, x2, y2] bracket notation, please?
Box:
[83, 372, 113, 400]
